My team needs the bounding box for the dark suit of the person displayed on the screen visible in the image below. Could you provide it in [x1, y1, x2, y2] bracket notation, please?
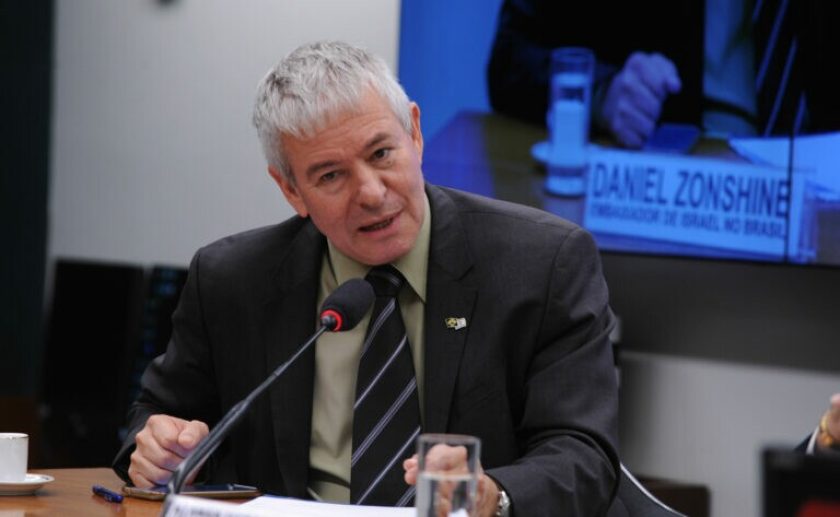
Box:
[487, 0, 840, 132]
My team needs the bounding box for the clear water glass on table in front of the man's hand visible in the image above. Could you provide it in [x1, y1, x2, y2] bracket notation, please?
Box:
[415, 434, 481, 517]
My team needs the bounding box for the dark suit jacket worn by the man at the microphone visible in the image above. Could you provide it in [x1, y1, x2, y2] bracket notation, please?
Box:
[115, 186, 618, 516]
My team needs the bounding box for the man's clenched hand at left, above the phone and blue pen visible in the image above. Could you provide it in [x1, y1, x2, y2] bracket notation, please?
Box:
[128, 415, 209, 488]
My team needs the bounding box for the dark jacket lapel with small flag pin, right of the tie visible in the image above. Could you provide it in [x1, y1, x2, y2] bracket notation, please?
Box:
[423, 185, 476, 432]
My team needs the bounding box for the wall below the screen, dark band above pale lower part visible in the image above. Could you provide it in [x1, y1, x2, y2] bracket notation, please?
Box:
[604, 254, 840, 517]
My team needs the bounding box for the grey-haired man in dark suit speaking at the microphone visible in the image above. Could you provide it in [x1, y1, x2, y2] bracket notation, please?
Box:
[114, 42, 619, 516]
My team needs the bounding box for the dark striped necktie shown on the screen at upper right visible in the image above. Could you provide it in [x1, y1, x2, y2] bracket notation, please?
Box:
[752, 0, 806, 136]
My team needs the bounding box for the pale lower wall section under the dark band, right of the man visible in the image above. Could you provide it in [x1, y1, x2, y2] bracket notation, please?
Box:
[620, 345, 840, 517]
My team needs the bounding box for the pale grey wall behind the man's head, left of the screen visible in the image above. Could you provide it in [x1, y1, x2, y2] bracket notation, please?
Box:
[48, 0, 399, 265]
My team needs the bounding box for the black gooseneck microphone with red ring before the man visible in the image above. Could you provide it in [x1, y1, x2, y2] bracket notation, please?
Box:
[167, 278, 375, 494]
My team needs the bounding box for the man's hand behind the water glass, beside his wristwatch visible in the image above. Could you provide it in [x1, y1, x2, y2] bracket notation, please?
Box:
[403, 445, 499, 517]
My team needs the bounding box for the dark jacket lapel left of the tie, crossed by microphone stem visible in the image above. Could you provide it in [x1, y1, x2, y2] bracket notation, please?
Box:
[261, 221, 326, 497]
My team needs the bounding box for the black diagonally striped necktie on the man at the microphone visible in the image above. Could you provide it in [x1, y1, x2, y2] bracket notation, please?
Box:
[350, 265, 420, 506]
